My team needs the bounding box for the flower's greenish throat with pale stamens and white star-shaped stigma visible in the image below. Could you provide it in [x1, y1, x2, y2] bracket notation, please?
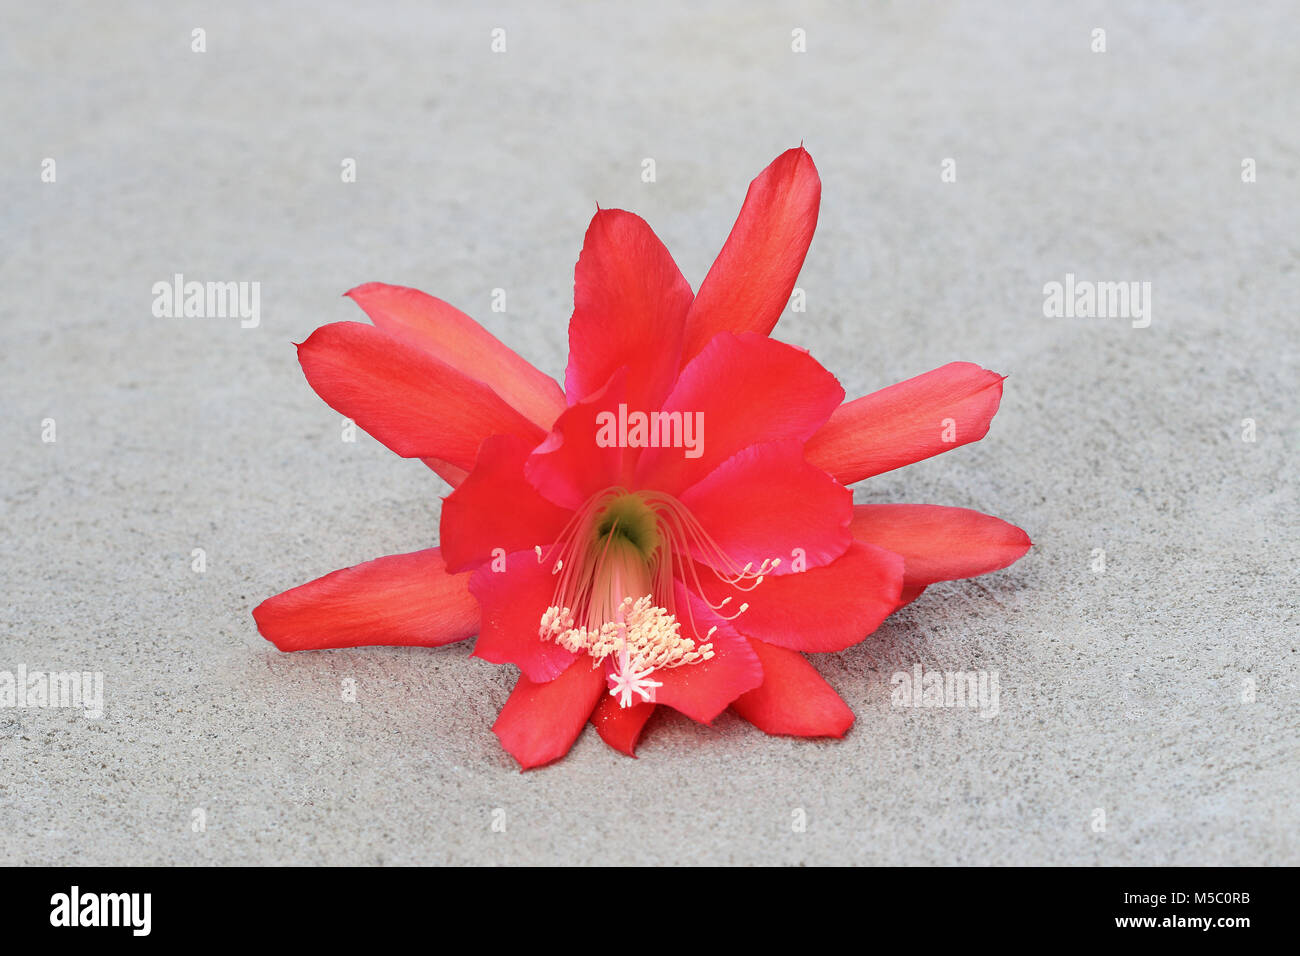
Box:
[534, 488, 780, 708]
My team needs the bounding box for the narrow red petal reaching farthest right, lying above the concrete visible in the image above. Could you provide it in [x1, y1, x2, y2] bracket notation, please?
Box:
[850, 505, 1031, 587]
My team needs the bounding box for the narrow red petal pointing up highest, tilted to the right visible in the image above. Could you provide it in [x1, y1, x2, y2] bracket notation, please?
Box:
[683, 146, 822, 360]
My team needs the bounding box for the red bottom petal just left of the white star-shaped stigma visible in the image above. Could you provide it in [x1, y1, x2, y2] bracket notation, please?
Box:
[491, 654, 605, 770]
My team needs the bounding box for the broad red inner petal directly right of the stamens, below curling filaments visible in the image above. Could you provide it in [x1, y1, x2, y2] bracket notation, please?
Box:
[697, 541, 902, 652]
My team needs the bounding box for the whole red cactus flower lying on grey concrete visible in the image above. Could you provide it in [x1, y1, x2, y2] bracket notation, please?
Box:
[254, 148, 1030, 769]
